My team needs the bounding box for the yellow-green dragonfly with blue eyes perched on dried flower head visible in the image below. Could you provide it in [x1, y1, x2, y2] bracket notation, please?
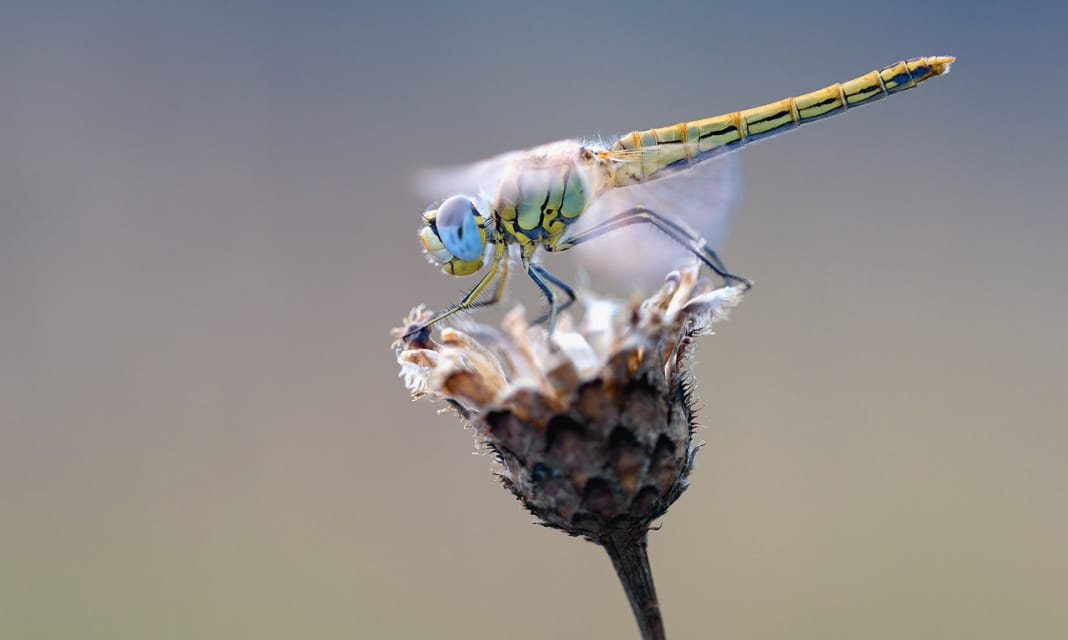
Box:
[408, 56, 955, 337]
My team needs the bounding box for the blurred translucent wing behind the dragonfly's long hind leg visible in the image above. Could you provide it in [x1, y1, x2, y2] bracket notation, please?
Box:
[569, 155, 741, 290]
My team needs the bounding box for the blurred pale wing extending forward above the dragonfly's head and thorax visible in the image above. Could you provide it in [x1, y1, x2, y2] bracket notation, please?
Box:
[414, 140, 582, 200]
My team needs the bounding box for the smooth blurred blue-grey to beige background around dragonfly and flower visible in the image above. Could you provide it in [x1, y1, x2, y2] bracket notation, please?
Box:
[0, 0, 1068, 639]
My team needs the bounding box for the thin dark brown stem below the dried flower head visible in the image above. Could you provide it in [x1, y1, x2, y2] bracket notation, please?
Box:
[598, 530, 665, 640]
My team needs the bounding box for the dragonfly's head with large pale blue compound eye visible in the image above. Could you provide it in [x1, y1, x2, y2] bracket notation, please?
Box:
[419, 196, 486, 276]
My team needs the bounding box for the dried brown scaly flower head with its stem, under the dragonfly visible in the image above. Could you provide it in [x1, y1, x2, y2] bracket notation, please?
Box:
[394, 266, 742, 637]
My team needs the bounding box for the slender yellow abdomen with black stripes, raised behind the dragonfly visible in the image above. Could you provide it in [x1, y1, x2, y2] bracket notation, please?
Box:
[608, 57, 954, 187]
